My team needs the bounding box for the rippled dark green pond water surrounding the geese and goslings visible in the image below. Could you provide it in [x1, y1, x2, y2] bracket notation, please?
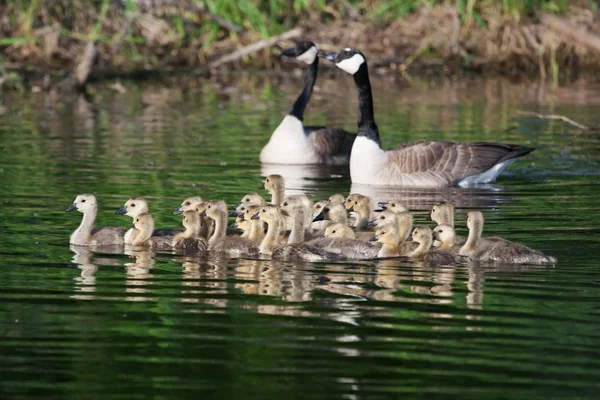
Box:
[0, 75, 600, 399]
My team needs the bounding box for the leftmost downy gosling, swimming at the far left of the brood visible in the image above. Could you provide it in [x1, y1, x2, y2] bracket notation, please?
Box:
[65, 194, 127, 246]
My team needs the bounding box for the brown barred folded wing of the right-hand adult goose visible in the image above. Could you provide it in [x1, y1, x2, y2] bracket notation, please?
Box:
[388, 141, 533, 179]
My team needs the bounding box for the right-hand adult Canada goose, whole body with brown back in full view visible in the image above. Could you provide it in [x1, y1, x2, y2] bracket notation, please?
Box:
[319, 49, 533, 187]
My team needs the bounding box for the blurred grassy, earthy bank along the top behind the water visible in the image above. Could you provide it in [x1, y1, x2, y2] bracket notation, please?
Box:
[0, 0, 600, 84]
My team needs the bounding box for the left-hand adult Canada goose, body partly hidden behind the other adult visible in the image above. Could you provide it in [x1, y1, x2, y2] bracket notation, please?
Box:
[260, 42, 356, 166]
